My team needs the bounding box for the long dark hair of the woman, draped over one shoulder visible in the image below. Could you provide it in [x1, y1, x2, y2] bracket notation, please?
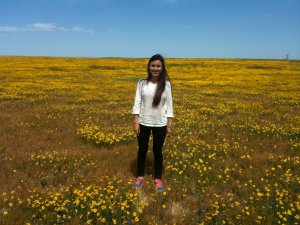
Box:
[146, 54, 170, 108]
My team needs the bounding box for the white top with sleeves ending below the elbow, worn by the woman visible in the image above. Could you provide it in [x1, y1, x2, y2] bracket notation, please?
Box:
[132, 79, 174, 127]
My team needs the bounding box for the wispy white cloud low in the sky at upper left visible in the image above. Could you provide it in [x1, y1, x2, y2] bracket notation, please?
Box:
[0, 23, 93, 34]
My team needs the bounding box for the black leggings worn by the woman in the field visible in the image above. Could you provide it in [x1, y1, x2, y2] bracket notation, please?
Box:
[137, 124, 167, 179]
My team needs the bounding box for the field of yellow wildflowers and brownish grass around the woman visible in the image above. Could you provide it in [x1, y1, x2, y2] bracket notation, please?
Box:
[0, 56, 300, 225]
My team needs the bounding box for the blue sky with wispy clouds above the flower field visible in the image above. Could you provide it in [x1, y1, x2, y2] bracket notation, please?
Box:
[0, 0, 300, 59]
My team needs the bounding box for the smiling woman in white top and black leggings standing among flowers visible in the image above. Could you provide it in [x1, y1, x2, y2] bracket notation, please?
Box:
[132, 54, 174, 190]
